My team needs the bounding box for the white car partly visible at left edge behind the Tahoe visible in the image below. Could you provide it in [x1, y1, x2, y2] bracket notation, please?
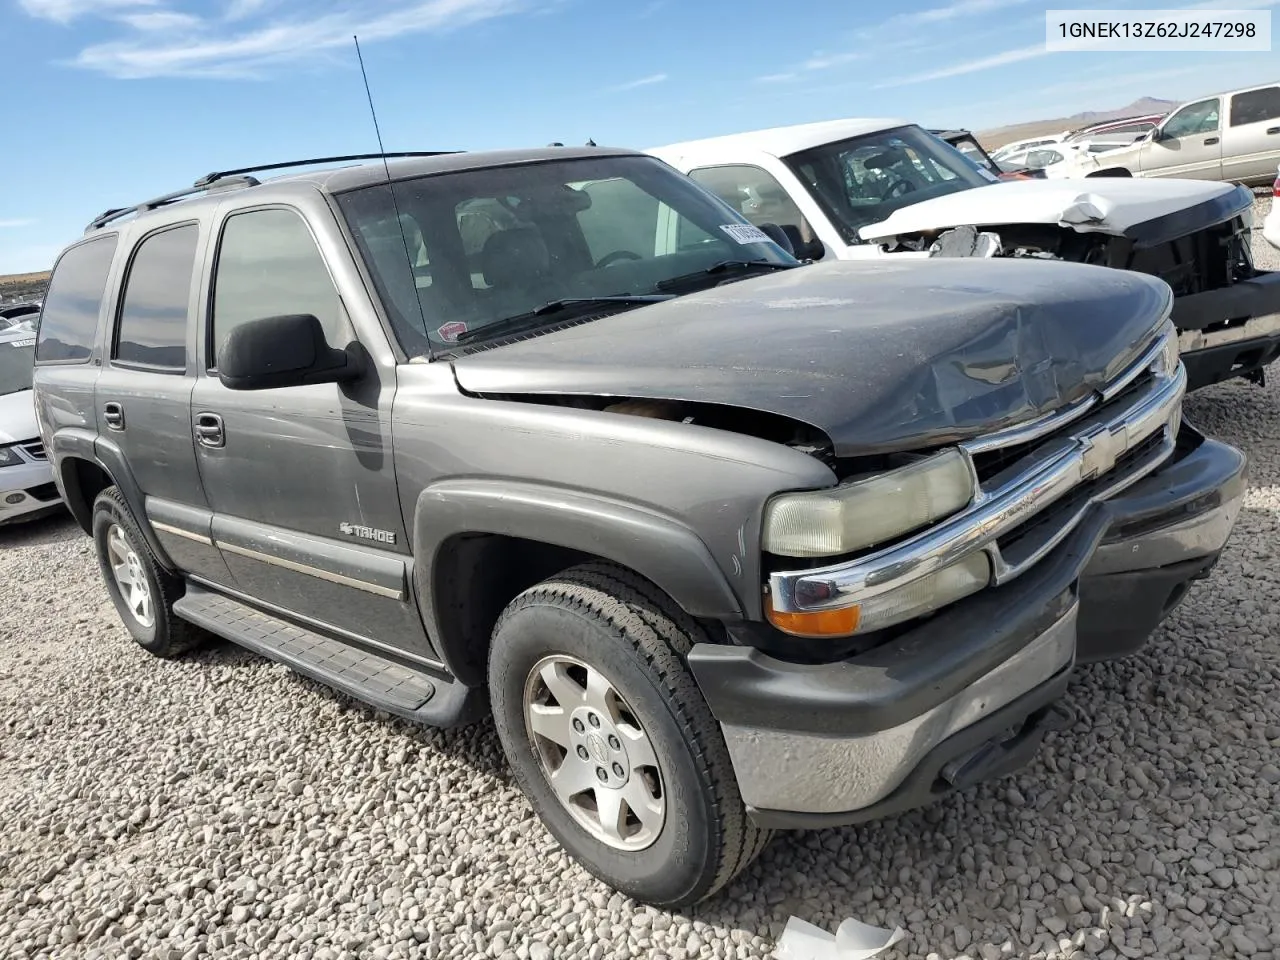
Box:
[0, 329, 61, 525]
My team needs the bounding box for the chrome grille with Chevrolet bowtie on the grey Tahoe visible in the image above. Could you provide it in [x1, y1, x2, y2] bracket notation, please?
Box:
[769, 323, 1187, 612]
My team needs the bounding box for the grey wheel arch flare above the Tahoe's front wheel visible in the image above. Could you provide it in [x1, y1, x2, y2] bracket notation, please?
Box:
[413, 480, 742, 686]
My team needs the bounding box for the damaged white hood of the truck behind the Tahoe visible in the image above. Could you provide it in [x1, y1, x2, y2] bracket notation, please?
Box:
[859, 177, 1253, 244]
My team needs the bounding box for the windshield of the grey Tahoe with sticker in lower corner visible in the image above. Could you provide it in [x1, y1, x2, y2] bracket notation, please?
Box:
[338, 156, 796, 356]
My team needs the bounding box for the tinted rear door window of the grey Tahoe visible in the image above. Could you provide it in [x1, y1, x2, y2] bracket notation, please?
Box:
[115, 224, 200, 371]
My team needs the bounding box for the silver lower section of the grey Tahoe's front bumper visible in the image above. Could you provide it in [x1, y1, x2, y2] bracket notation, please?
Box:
[722, 603, 1078, 814]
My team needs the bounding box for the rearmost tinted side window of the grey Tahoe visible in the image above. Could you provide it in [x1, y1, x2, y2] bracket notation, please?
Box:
[36, 233, 116, 362]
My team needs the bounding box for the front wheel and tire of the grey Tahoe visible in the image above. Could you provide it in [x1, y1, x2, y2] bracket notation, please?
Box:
[489, 563, 771, 906]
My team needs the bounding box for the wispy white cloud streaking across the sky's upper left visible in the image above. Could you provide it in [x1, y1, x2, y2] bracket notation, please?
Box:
[20, 0, 549, 79]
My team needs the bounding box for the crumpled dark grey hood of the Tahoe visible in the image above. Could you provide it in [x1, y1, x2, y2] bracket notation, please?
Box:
[453, 260, 1172, 456]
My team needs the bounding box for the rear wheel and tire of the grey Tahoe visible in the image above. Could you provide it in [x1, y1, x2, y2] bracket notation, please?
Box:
[92, 486, 206, 659]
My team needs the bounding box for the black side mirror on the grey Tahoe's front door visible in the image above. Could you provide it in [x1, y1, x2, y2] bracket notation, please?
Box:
[218, 314, 364, 390]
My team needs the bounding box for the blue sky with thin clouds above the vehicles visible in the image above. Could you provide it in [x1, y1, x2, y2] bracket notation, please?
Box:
[0, 0, 1280, 274]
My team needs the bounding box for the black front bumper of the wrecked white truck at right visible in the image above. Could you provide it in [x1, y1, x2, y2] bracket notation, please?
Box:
[1172, 271, 1280, 390]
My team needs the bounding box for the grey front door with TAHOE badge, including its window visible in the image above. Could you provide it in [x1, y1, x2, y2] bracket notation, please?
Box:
[191, 206, 429, 655]
